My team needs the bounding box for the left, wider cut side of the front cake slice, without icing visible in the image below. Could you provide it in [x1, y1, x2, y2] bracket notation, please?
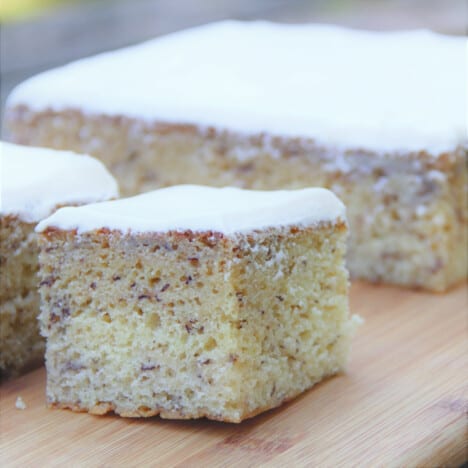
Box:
[40, 230, 250, 421]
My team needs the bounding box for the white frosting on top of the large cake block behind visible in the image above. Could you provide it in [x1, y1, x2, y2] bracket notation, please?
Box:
[8, 21, 467, 155]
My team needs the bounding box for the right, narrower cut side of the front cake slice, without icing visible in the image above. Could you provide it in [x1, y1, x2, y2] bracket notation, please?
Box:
[231, 221, 356, 415]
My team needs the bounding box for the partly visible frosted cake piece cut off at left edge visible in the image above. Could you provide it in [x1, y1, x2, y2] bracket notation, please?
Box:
[0, 142, 117, 377]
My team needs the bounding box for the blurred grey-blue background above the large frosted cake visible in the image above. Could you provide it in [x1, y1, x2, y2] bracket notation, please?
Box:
[0, 0, 468, 110]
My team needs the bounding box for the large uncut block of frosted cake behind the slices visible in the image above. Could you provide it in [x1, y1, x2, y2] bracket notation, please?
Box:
[6, 21, 468, 291]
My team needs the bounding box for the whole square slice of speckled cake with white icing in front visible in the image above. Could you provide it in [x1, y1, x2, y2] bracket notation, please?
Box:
[37, 186, 360, 422]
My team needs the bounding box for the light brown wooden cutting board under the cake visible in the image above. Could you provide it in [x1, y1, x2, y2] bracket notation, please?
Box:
[0, 283, 468, 468]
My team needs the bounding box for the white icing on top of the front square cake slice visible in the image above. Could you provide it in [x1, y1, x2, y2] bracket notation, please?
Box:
[36, 185, 346, 234]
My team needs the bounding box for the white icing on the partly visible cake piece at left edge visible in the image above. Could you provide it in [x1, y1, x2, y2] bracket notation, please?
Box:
[0, 142, 118, 222]
